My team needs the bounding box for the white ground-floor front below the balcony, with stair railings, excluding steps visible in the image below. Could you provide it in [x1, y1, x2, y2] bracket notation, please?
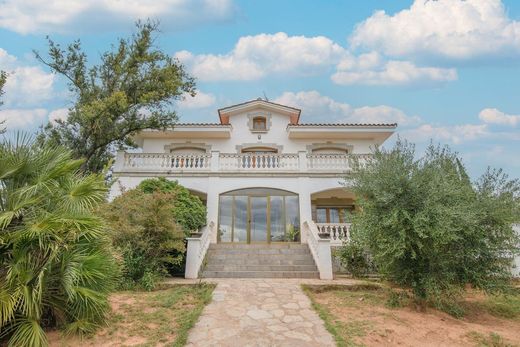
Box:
[112, 175, 356, 278]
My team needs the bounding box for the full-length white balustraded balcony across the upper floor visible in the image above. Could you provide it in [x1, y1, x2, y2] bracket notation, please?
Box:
[114, 151, 370, 174]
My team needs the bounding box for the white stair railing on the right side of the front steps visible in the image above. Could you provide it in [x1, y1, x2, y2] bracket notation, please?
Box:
[303, 221, 333, 280]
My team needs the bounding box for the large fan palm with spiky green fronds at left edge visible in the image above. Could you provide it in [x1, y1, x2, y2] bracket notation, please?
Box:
[0, 135, 118, 346]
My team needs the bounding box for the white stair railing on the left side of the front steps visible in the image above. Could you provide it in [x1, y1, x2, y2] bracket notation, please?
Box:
[184, 222, 215, 278]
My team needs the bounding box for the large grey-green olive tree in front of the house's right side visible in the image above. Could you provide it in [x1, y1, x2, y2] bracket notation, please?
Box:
[348, 140, 520, 314]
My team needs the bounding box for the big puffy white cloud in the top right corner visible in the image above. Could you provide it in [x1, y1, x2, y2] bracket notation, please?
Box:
[349, 0, 520, 60]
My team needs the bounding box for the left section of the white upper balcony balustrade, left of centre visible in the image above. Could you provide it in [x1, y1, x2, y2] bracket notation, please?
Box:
[122, 153, 211, 171]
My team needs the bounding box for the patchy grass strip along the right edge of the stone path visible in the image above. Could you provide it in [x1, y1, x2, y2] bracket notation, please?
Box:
[302, 285, 372, 347]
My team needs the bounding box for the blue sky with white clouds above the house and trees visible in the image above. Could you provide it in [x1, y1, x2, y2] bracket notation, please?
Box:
[0, 0, 520, 177]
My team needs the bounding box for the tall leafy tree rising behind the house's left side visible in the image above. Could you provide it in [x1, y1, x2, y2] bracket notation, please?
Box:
[35, 22, 195, 172]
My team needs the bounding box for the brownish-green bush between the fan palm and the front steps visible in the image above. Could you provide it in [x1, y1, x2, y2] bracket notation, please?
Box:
[99, 189, 185, 290]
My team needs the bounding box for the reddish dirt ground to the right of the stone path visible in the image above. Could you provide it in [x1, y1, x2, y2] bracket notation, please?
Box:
[307, 290, 520, 346]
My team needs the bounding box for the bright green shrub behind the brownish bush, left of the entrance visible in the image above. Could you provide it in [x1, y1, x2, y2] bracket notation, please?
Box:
[139, 177, 206, 236]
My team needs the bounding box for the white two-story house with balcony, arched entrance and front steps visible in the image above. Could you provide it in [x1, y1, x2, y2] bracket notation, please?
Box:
[111, 99, 397, 278]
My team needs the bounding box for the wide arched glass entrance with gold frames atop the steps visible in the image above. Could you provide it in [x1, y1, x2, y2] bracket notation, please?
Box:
[218, 188, 300, 243]
